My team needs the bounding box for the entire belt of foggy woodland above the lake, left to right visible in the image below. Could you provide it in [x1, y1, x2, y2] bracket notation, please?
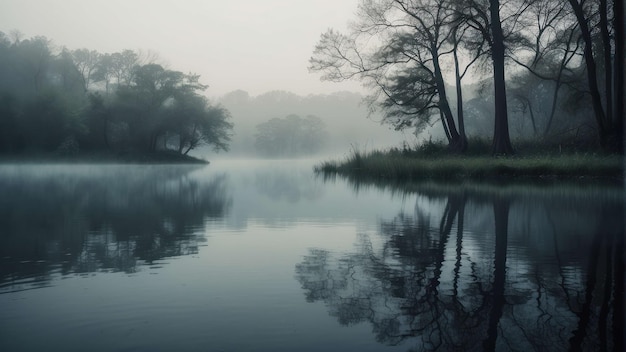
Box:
[0, 0, 624, 157]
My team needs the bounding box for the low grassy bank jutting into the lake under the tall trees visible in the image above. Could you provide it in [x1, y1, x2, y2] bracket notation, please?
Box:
[315, 149, 624, 181]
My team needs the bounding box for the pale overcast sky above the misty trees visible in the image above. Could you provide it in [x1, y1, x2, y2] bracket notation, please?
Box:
[0, 0, 362, 97]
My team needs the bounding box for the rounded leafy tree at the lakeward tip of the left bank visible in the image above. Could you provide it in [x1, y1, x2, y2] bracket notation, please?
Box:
[106, 64, 233, 154]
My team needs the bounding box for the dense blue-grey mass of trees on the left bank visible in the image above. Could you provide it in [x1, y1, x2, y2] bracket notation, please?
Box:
[0, 32, 233, 155]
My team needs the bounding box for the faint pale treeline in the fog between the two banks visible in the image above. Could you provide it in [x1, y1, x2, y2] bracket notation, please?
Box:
[219, 90, 402, 157]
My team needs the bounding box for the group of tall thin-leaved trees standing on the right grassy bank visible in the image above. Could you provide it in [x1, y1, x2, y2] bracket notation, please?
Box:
[309, 0, 624, 154]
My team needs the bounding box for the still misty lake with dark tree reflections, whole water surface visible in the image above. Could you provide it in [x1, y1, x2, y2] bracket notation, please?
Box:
[0, 160, 626, 351]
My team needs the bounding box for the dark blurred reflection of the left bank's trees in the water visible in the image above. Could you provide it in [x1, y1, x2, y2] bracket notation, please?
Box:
[0, 165, 231, 293]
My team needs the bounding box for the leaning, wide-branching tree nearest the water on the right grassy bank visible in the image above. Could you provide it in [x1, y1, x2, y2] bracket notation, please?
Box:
[310, 0, 467, 151]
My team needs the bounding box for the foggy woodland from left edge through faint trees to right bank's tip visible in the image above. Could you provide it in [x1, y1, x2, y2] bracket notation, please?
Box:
[0, 33, 403, 157]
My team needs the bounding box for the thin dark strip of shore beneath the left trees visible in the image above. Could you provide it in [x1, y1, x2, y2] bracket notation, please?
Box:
[0, 151, 209, 164]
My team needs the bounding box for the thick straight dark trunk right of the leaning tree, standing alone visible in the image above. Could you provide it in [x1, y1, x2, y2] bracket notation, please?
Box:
[489, 0, 513, 155]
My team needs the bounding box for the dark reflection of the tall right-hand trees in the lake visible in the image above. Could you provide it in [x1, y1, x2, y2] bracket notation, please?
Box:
[296, 181, 625, 351]
